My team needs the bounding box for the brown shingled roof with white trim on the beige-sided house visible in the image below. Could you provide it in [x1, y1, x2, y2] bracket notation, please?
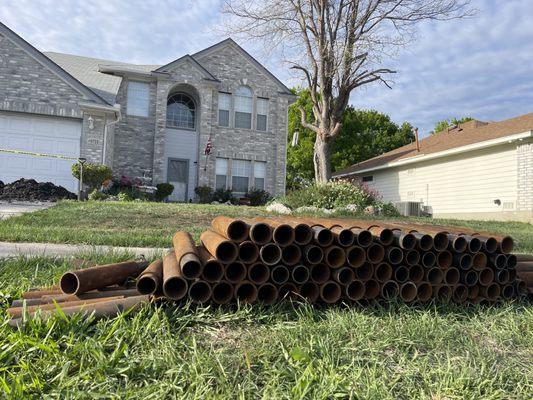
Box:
[333, 113, 533, 177]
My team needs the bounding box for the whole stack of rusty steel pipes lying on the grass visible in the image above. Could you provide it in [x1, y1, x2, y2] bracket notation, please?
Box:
[8, 216, 533, 324]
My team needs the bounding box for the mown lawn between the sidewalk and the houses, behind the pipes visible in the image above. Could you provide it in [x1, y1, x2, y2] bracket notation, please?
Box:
[0, 202, 533, 253]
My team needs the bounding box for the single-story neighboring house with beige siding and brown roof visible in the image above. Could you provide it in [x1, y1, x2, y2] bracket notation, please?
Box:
[334, 113, 533, 222]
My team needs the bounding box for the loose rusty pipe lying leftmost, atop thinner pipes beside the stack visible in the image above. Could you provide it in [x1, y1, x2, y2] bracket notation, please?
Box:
[59, 261, 148, 295]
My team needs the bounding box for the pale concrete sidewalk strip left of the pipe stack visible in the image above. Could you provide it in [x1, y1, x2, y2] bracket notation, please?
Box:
[0, 242, 167, 258]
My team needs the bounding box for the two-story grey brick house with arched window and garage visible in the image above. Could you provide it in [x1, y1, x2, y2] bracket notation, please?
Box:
[0, 24, 294, 201]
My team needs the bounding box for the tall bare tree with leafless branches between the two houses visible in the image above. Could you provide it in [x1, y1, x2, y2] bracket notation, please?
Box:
[223, 0, 472, 182]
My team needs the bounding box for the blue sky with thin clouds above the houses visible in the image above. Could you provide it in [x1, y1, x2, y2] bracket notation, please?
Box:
[0, 0, 533, 134]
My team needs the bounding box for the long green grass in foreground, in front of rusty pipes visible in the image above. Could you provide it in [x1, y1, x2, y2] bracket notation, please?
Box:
[0, 255, 533, 400]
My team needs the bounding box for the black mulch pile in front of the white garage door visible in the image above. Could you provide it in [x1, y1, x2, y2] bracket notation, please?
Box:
[0, 178, 76, 201]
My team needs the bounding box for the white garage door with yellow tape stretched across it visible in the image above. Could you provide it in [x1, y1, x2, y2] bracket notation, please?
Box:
[0, 112, 81, 193]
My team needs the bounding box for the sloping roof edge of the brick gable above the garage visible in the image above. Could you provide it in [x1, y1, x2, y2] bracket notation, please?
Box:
[0, 22, 111, 105]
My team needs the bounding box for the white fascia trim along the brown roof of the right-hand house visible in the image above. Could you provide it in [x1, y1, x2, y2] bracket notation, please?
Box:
[333, 131, 533, 178]
